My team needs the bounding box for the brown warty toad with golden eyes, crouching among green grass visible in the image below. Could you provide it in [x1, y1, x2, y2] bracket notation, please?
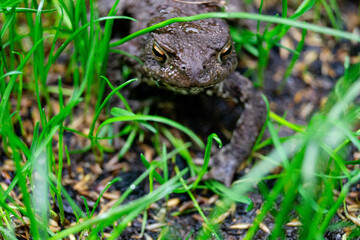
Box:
[99, 0, 266, 185]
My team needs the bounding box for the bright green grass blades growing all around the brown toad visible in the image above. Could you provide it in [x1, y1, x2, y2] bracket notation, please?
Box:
[0, 0, 360, 239]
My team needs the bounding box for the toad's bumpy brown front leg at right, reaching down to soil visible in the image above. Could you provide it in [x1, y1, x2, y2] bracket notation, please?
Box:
[210, 72, 266, 186]
